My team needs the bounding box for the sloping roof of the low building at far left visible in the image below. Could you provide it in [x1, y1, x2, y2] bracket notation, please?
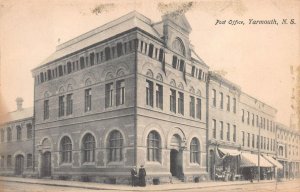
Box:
[0, 107, 33, 124]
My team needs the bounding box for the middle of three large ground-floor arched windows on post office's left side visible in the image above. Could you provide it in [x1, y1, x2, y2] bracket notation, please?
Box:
[82, 133, 95, 162]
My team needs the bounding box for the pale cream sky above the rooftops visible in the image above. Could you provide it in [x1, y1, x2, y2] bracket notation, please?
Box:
[0, 0, 300, 125]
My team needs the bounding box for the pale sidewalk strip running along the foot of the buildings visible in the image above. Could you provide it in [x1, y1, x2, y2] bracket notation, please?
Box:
[0, 177, 275, 191]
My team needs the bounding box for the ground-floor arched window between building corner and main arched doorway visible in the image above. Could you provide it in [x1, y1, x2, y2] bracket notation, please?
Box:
[147, 131, 161, 161]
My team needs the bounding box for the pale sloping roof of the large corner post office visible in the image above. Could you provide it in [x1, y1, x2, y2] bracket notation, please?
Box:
[37, 11, 160, 68]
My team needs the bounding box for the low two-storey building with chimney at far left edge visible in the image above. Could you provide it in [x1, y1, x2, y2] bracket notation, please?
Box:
[0, 98, 34, 176]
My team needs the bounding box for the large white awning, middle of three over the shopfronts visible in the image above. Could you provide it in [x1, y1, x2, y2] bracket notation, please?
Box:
[240, 153, 273, 167]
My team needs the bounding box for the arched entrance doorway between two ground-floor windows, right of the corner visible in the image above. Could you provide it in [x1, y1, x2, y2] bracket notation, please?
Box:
[170, 134, 183, 178]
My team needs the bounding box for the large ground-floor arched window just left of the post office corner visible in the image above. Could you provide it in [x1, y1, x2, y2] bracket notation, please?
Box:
[108, 130, 123, 161]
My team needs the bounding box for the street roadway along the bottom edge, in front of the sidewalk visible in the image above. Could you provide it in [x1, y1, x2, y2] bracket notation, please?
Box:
[0, 180, 300, 192]
